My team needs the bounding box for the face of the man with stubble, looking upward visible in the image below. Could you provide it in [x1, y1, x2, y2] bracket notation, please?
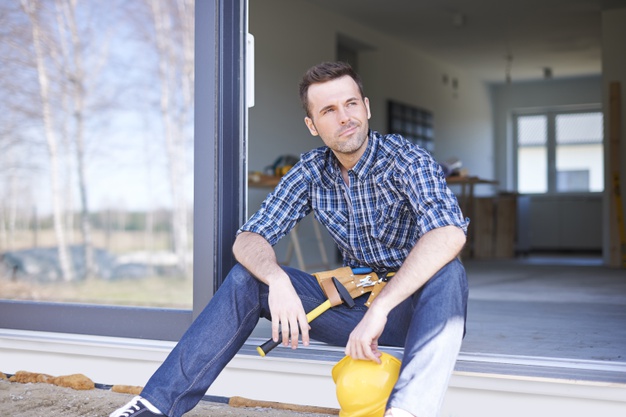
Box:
[304, 76, 371, 159]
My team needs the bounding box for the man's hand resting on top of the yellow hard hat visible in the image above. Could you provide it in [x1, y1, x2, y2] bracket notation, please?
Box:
[345, 309, 387, 363]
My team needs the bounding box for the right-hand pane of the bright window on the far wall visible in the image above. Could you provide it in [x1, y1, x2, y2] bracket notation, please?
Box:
[556, 112, 604, 192]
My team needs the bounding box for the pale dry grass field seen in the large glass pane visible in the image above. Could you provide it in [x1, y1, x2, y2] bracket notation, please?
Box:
[0, 230, 193, 309]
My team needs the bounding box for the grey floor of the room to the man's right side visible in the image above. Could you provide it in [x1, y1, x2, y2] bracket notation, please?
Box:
[457, 257, 626, 382]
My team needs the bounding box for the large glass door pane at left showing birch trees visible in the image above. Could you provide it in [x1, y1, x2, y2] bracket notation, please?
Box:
[0, 0, 194, 308]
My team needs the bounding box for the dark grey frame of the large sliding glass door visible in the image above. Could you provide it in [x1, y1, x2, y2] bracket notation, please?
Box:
[0, 0, 248, 340]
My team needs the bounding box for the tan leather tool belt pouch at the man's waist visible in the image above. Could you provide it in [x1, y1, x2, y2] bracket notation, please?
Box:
[313, 266, 385, 307]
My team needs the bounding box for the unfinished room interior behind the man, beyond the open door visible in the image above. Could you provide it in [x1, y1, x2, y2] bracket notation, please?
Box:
[248, 0, 626, 400]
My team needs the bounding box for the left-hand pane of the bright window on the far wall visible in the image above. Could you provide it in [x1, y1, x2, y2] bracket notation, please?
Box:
[517, 115, 548, 193]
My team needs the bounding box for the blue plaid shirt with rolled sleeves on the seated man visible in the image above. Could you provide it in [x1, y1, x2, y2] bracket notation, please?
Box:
[238, 131, 469, 270]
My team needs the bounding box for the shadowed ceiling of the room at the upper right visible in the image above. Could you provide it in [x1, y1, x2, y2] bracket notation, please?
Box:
[307, 0, 626, 83]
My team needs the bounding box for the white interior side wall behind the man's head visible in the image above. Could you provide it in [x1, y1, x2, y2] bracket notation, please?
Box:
[248, 0, 494, 263]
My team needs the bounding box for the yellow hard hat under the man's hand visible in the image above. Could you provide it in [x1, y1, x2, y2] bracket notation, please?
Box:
[332, 352, 400, 417]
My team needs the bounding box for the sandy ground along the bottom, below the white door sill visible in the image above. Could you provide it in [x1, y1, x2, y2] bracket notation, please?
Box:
[0, 379, 333, 417]
